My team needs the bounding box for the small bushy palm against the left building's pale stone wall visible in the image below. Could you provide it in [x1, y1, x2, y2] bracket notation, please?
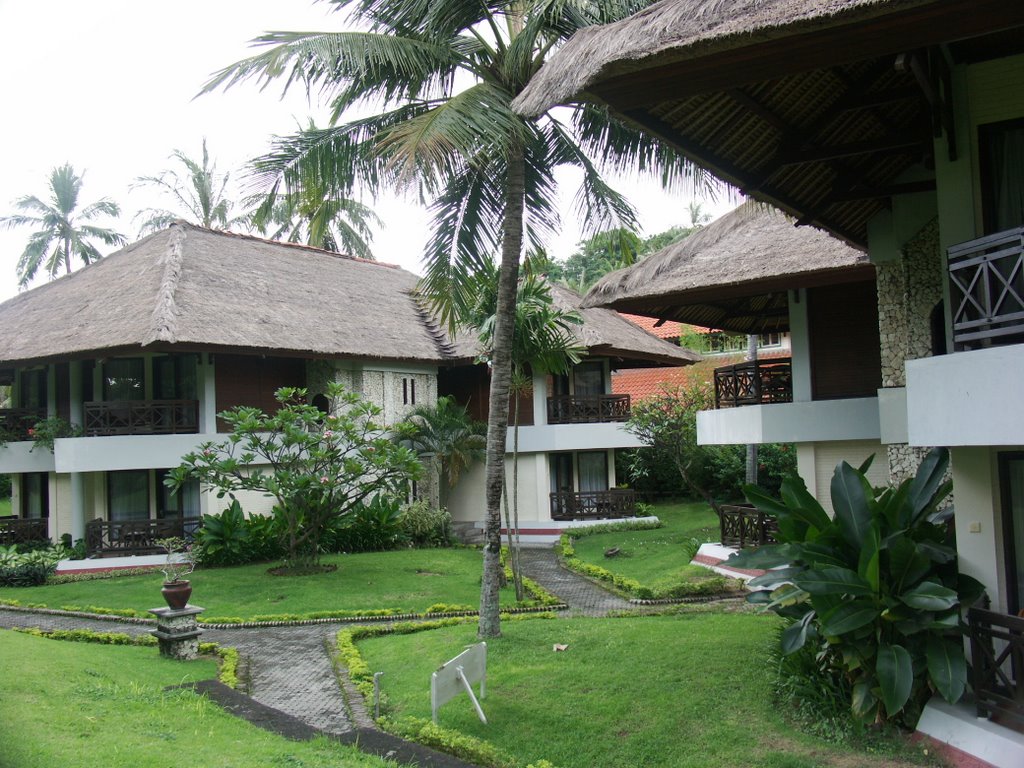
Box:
[402, 396, 486, 505]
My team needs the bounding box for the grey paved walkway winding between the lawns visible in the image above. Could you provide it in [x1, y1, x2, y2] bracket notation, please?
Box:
[0, 548, 635, 757]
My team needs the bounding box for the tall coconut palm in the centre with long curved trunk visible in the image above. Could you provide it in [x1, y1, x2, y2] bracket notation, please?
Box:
[205, 0, 710, 637]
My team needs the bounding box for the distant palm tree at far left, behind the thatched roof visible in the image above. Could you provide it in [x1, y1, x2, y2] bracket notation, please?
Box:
[0, 163, 126, 288]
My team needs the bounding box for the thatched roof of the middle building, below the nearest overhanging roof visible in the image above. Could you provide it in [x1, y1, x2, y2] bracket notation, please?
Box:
[584, 205, 874, 333]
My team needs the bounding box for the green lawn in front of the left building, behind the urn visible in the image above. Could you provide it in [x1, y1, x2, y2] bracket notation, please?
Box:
[0, 549, 528, 621]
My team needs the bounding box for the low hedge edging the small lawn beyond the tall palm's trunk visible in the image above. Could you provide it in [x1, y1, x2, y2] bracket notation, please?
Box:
[555, 521, 740, 605]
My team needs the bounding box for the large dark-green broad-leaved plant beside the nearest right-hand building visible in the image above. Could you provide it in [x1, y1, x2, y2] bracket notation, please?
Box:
[728, 449, 984, 724]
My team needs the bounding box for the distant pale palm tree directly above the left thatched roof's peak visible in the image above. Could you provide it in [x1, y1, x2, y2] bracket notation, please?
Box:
[132, 138, 246, 236]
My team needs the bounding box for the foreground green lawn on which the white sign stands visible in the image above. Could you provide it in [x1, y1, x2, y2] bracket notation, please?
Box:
[358, 611, 937, 768]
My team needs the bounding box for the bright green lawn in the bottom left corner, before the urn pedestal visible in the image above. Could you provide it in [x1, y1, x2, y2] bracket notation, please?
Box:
[0, 630, 390, 768]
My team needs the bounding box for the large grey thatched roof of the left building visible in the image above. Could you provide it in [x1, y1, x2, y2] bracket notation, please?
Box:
[0, 222, 453, 364]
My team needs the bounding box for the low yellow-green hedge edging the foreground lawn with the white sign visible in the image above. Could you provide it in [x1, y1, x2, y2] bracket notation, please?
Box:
[336, 611, 557, 768]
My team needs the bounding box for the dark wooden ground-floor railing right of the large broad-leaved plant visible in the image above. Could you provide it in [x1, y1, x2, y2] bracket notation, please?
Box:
[968, 608, 1024, 731]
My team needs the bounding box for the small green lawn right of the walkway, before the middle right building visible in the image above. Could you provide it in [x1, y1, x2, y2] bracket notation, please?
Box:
[573, 502, 719, 591]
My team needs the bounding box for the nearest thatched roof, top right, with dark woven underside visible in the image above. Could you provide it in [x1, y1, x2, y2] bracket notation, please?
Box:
[515, 0, 1024, 246]
